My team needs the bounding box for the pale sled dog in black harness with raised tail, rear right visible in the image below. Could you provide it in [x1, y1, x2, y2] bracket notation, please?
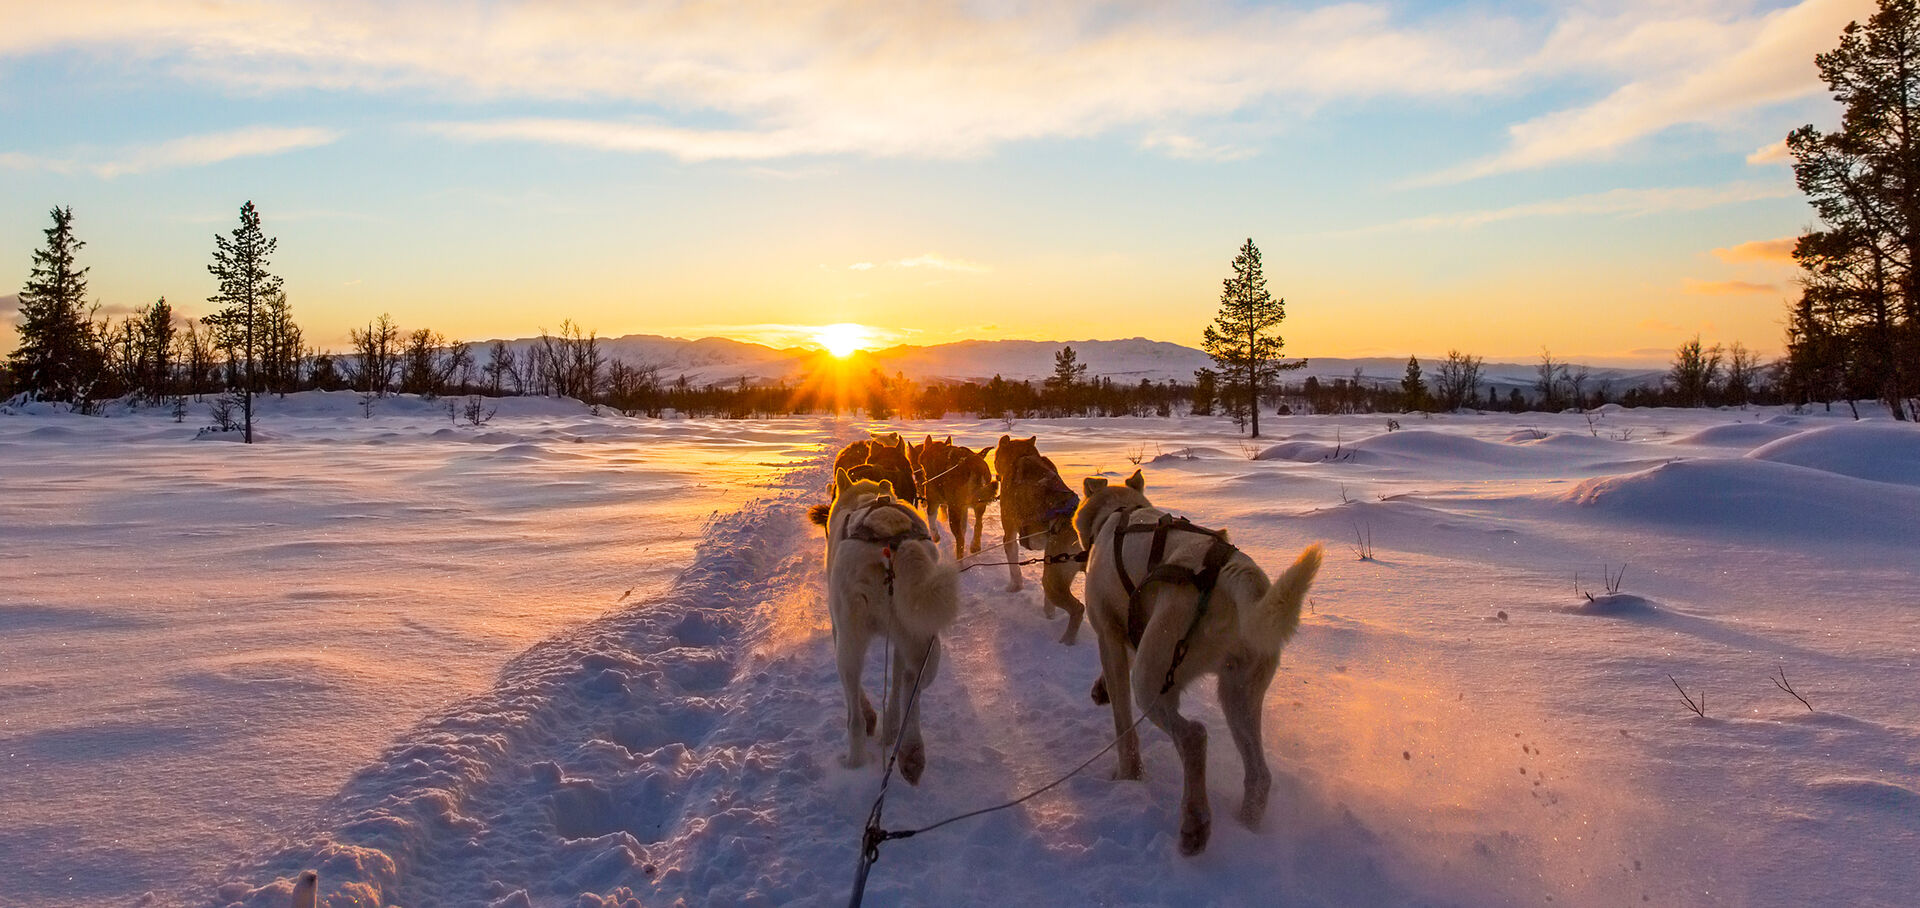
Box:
[1073, 470, 1321, 854]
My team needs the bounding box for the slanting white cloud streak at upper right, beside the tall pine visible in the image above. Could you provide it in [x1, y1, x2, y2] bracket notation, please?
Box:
[1419, 0, 1874, 184]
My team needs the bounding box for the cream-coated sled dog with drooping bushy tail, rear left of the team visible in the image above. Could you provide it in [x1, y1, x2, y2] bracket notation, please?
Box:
[826, 470, 960, 785]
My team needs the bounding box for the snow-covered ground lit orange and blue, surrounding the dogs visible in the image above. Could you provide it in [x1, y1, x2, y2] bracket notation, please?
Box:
[0, 395, 1920, 906]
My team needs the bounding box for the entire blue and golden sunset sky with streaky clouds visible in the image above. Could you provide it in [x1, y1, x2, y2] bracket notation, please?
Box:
[0, 0, 1872, 363]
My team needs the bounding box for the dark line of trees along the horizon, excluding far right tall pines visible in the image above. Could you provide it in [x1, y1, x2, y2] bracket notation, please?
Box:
[0, 209, 1789, 430]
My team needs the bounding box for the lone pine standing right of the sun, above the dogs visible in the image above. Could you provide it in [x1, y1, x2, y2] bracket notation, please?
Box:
[1202, 238, 1308, 438]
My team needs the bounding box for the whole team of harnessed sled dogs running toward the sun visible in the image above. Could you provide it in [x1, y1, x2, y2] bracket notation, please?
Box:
[810, 434, 1321, 854]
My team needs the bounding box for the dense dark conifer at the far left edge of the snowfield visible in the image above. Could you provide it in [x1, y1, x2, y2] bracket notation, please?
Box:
[10, 207, 106, 407]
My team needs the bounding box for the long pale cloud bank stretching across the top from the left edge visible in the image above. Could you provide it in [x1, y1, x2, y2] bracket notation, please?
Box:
[0, 0, 1524, 161]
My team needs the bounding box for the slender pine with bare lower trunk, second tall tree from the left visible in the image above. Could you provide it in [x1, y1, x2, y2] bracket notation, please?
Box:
[202, 202, 284, 443]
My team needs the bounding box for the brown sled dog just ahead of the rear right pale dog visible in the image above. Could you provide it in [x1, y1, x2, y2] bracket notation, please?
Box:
[993, 436, 1087, 645]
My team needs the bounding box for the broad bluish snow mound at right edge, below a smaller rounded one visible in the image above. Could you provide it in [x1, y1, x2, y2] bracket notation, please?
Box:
[1555, 459, 1920, 547]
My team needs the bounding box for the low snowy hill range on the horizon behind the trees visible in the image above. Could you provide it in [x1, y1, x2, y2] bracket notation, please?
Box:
[474, 334, 1665, 394]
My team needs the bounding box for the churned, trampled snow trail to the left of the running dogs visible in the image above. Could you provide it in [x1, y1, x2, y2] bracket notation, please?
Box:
[213, 441, 826, 908]
